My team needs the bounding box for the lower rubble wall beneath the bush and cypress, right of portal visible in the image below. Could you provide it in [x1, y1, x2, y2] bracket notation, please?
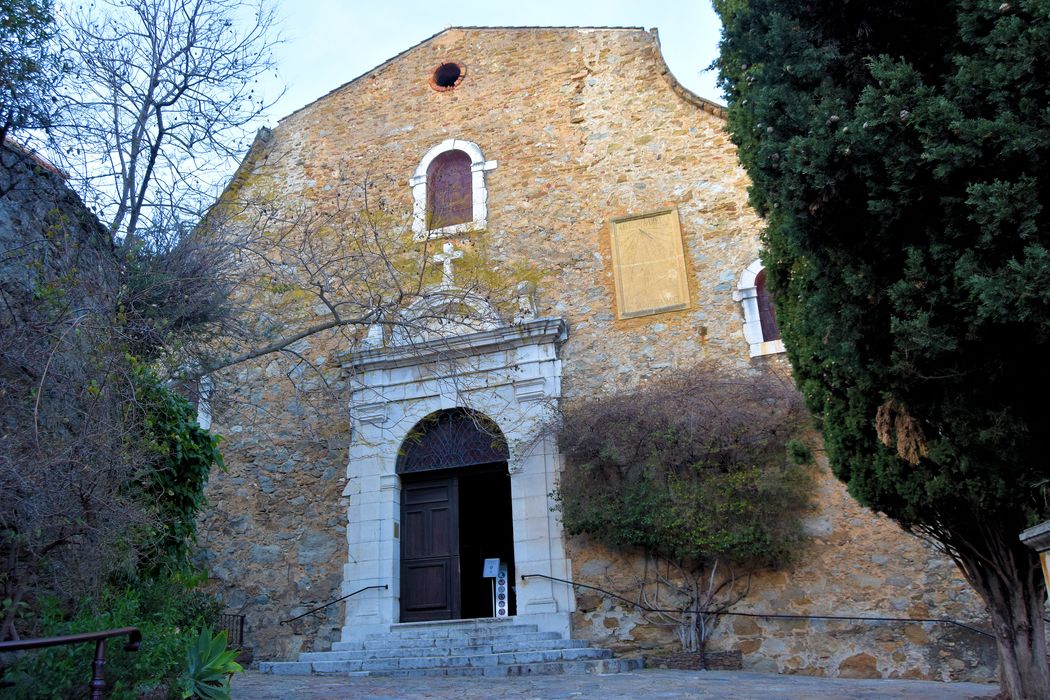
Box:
[569, 451, 996, 681]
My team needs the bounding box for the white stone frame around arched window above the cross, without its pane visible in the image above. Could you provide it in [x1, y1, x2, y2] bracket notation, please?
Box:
[408, 139, 498, 240]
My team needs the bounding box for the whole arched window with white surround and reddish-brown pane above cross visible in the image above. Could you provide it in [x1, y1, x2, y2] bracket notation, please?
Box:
[408, 139, 497, 240]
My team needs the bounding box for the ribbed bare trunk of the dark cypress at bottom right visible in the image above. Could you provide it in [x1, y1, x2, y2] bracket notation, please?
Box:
[957, 531, 1050, 700]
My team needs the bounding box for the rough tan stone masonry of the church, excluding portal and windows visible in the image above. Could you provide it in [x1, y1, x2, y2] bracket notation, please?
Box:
[201, 28, 993, 679]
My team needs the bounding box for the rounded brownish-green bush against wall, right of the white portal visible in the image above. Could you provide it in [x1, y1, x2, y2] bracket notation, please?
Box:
[553, 364, 811, 651]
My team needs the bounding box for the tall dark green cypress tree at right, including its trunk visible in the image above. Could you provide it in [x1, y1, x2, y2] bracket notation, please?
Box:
[715, 0, 1050, 699]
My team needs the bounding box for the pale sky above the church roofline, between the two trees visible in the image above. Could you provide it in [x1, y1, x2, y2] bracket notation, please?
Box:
[267, 0, 722, 124]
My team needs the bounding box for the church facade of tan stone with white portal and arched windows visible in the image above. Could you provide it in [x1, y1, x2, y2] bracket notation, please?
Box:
[200, 27, 994, 679]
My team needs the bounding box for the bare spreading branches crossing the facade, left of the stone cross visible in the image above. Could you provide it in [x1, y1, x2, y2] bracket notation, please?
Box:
[191, 158, 537, 434]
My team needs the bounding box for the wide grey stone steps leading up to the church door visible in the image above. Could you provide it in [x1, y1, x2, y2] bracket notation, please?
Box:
[259, 619, 643, 677]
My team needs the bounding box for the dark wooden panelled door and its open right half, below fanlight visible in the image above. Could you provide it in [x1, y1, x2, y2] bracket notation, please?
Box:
[401, 463, 513, 622]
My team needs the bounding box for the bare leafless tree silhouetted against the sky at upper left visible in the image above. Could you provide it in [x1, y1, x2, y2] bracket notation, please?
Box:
[55, 0, 277, 248]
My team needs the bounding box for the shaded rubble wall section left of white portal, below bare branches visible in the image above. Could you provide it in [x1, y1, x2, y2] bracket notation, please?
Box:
[197, 358, 349, 659]
